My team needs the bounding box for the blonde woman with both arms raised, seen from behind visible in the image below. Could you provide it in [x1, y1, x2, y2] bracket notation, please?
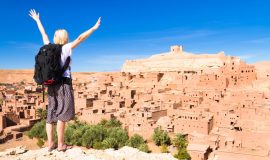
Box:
[29, 9, 101, 151]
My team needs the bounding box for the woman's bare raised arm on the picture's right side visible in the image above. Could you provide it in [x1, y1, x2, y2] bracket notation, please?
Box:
[71, 17, 101, 49]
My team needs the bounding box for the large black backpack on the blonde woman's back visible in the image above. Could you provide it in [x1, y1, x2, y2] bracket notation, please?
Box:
[34, 44, 70, 86]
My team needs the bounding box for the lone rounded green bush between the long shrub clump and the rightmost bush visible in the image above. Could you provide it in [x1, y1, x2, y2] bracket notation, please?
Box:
[152, 127, 171, 146]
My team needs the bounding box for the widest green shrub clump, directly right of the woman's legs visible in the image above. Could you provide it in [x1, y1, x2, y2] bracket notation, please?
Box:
[65, 119, 129, 149]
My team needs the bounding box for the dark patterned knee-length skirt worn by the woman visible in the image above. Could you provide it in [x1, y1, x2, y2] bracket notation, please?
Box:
[46, 84, 75, 124]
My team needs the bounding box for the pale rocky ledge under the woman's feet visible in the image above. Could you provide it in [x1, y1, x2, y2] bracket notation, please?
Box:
[0, 146, 176, 160]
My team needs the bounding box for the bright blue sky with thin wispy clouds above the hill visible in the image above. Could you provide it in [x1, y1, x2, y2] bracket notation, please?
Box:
[0, 0, 270, 71]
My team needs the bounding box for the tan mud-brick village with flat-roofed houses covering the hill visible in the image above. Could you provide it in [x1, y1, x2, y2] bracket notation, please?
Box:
[0, 46, 270, 160]
